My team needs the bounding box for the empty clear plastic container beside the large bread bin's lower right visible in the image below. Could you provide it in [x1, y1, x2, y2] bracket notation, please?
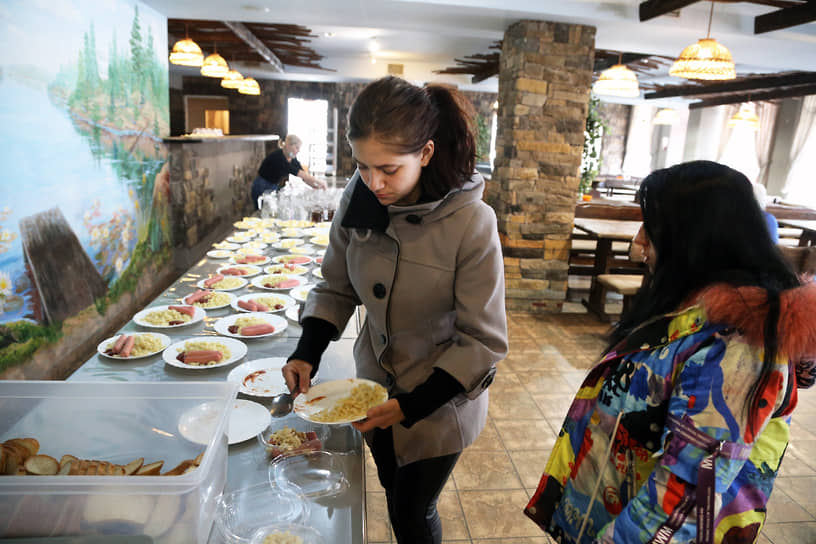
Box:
[216, 482, 309, 544]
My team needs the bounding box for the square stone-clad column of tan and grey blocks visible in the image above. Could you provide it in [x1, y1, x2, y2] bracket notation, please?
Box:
[486, 21, 595, 313]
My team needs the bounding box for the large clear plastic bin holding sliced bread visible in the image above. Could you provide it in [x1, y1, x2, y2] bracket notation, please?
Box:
[0, 381, 237, 544]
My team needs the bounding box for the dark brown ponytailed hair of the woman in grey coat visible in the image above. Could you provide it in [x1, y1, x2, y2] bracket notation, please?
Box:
[346, 76, 476, 200]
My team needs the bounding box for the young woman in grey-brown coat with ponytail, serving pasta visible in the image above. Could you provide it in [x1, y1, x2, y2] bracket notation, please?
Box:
[283, 77, 507, 544]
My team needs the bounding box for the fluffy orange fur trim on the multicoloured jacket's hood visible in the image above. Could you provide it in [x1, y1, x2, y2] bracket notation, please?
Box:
[697, 282, 816, 361]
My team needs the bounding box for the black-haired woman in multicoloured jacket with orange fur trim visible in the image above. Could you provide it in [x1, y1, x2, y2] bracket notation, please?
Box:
[525, 161, 816, 544]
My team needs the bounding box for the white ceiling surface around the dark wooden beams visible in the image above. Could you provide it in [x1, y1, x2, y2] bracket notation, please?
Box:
[143, 0, 816, 99]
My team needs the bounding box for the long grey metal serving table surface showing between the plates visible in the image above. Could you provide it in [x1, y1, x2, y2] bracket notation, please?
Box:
[68, 222, 365, 544]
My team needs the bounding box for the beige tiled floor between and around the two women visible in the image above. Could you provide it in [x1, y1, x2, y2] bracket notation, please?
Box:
[366, 313, 816, 544]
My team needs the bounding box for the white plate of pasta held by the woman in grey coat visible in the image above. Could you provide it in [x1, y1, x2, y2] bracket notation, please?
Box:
[292, 378, 388, 425]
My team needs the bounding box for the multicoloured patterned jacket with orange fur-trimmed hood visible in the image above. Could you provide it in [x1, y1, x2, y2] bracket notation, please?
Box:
[525, 284, 816, 544]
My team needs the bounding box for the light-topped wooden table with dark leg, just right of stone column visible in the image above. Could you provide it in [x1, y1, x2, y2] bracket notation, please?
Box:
[575, 218, 641, 321]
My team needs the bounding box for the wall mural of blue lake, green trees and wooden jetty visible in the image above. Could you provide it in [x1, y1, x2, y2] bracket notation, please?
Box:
[0, 0, 170, 348]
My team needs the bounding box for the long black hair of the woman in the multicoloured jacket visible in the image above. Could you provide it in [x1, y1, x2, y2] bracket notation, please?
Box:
[608, 161, 799, 430]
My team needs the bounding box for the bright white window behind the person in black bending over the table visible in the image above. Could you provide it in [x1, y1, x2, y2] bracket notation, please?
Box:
[286, 98, 329, 175]
